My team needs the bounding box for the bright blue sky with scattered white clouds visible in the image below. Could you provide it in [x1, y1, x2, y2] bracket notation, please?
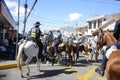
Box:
[5, 0, 120, 33]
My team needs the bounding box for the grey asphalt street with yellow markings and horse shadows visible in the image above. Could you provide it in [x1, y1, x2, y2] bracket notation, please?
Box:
[0, 54, 106, 80]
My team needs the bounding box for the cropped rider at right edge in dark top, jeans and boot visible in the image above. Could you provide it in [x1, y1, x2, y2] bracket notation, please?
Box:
[95, 19, 120, 76]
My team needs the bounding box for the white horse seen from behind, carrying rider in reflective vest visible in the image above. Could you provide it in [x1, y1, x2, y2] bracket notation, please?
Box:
[17, 41, 40, 80]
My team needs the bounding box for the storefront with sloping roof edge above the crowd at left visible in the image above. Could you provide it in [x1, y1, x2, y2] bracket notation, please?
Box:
[0, 0, 17, 40]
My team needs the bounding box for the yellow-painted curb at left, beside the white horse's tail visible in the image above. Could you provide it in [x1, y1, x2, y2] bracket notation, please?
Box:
[0, 61, 25, 70]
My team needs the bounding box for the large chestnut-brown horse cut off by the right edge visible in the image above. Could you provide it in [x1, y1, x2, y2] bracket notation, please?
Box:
[98, 30, 120, 80]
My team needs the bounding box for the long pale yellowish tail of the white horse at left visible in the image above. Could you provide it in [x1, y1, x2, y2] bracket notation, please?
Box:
[17, 44, 24, 75]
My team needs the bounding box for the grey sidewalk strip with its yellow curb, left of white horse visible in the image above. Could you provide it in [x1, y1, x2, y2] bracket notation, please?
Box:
[0, 60, 25, 70]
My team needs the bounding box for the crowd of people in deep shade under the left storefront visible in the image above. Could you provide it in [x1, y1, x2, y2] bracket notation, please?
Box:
[0, 35, 16, 60]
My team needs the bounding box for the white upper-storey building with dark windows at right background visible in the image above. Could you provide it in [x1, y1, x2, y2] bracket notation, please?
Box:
[87, 13, 120, 35]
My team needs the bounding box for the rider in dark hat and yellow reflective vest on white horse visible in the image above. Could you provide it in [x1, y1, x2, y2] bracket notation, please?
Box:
[30, 22, 43, 61]
